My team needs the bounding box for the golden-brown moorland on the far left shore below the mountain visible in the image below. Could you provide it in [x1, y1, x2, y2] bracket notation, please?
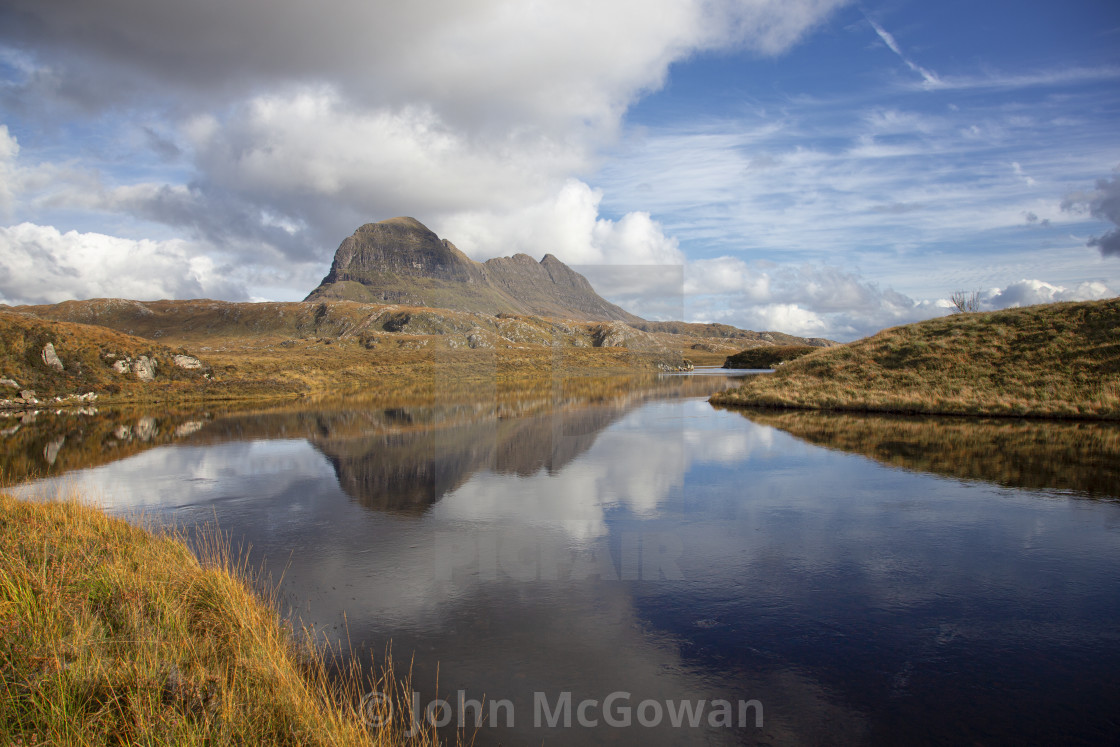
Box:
[0, 299, 828, 404]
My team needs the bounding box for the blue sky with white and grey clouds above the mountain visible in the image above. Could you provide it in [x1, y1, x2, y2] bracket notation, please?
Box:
[0, 0, 1120, 340]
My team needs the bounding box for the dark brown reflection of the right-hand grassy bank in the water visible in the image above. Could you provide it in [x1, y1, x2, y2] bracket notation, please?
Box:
[725, 410, 1120, 497]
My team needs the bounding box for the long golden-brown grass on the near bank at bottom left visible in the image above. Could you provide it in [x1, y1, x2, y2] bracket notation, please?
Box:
[0, 495, 454, 745]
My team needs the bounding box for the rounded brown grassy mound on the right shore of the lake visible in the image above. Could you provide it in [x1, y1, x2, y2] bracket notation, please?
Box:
[711, 299, 1120, 420]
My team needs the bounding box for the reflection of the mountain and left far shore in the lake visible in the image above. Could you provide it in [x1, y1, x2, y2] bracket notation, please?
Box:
[0, 374, 731, 506]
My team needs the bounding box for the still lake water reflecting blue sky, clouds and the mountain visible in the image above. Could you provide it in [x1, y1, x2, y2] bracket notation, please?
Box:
[0, 376, 1120, 745]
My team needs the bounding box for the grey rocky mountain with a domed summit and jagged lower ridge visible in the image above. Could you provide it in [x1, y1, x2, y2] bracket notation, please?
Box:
[305, 217, 642, 324]
